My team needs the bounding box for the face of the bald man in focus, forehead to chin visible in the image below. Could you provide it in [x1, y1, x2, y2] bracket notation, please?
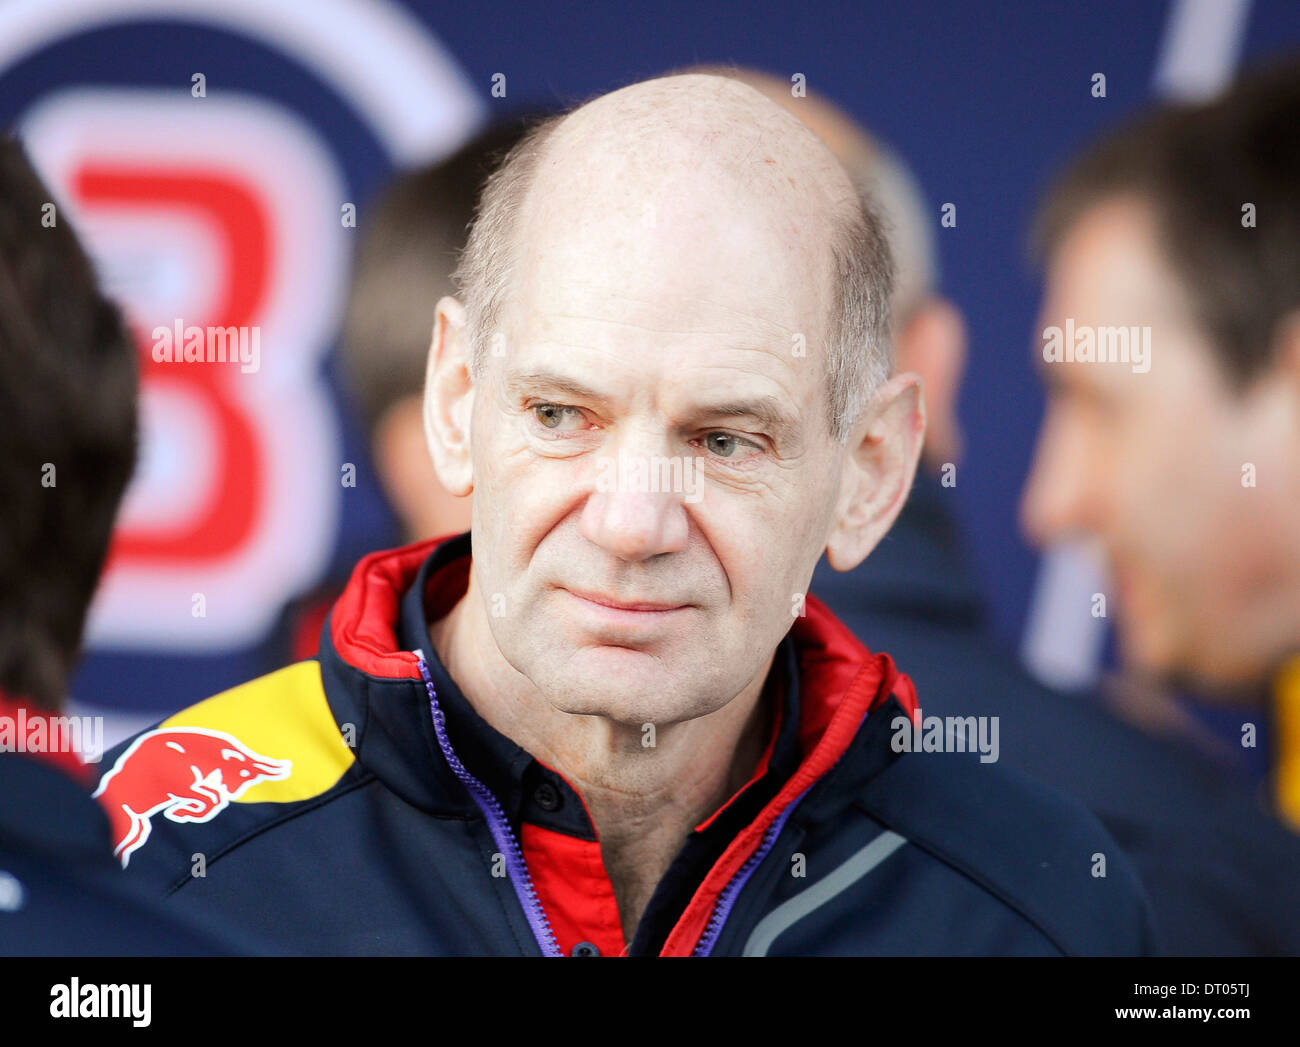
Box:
[471, 139, 842, 724]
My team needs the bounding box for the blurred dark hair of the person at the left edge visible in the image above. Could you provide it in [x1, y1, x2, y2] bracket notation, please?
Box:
[0, 138, 138, 708]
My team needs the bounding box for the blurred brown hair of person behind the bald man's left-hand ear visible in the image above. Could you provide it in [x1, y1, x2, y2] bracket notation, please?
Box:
[342, 116, 540, 432]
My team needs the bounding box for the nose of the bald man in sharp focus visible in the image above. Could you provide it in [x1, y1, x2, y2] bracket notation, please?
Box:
[581, 450, 696, 562]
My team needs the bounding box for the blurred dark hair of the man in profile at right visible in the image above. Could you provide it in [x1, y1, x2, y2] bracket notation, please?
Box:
[1031, 59, 1300, 389]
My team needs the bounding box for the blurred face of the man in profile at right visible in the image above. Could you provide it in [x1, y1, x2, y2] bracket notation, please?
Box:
[1022, 199, 1288, 683]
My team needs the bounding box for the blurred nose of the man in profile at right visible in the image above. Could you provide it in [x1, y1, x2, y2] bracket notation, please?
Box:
[1021, 407, 1096, 546]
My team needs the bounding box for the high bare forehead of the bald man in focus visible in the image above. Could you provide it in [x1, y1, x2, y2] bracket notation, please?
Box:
[516, 87, 852, 343]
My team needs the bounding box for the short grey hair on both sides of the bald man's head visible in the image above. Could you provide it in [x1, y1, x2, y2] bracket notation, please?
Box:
[452, 77, 893, 444]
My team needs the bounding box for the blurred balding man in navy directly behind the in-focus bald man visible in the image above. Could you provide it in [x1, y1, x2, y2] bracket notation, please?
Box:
[715, 69, 1300, 955]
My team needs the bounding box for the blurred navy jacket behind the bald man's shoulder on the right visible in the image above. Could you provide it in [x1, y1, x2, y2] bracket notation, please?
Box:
[813, 476, 1300, 956]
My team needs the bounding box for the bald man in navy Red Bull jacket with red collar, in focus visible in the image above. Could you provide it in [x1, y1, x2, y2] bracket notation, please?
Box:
[100, 75, 1153, 956]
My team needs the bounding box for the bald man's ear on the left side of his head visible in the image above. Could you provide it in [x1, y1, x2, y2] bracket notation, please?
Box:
[424, 297, 475, 496]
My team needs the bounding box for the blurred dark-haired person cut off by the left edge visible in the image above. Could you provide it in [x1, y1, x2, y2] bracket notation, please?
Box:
[0, 139, 241, 956]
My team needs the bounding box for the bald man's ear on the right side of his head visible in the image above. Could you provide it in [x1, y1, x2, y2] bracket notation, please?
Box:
[826, 372, 926, 571]
